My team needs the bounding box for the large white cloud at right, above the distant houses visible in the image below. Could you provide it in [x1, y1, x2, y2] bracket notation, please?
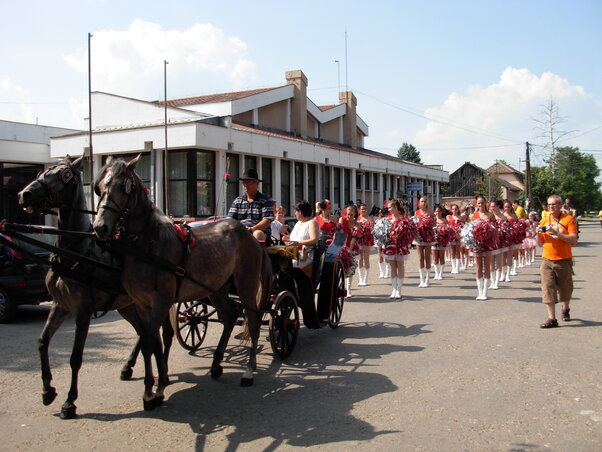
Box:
[413, 67, 596, 171]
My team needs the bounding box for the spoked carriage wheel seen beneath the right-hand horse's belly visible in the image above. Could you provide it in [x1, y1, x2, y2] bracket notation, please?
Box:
[169, 301, 209, 352]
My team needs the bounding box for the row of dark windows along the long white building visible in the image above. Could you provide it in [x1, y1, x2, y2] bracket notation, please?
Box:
[90, 149, 418, 217]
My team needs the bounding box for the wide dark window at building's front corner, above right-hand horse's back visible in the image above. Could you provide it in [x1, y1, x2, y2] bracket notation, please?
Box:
[168, 150, 215, 217]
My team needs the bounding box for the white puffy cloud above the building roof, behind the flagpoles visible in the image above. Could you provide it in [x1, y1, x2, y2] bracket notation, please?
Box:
[64, 19, 256, 98]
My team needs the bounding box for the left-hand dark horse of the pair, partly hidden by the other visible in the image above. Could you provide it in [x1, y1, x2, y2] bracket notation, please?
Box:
[19, 157, 173, 419]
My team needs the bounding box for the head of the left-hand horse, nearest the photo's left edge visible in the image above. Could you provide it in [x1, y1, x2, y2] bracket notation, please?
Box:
[18, 156, 84, 213]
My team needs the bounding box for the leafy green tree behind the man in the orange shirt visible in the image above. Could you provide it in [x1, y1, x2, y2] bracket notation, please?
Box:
[531, 146, 602, 212]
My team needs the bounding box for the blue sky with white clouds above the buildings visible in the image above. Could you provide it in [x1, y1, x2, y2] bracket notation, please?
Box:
[0, 0, 602, 172]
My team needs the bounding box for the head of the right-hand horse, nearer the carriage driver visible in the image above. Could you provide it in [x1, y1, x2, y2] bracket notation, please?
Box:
[93, 155, 145, 240]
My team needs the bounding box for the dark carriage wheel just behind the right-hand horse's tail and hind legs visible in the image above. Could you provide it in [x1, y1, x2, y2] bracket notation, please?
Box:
[269, 291, 299, 359]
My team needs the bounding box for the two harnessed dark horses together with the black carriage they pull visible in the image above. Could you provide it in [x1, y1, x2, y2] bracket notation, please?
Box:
[2, 157, 345, 419]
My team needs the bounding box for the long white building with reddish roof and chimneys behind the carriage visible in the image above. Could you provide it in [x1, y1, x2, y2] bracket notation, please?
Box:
[50, 71, 448, 218]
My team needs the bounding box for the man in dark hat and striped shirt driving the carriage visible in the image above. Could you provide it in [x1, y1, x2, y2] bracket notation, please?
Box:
[228, 168, 274, 240]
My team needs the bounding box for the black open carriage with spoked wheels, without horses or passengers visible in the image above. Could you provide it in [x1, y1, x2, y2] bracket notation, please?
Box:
[170, 230, 346, 359]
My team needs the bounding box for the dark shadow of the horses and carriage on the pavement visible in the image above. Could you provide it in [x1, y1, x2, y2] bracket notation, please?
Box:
[80, 322, 430, 451]
